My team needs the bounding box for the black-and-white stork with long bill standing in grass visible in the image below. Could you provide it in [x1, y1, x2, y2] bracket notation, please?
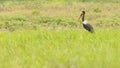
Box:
[79, 11, 94, 33]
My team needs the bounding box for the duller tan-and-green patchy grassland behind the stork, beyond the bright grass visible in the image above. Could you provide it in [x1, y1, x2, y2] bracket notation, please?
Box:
[0, 1, 120, 31]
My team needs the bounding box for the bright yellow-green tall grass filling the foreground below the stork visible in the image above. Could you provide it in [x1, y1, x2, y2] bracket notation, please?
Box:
[0, 29, 120, 68]
